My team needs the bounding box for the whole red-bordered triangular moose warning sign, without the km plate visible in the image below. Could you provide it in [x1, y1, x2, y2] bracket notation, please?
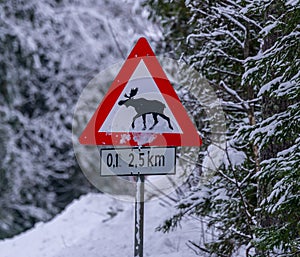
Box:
[79, 38, 202, 146]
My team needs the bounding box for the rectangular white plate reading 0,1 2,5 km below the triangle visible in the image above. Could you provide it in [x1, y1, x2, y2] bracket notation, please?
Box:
[100, 147, 176, 176]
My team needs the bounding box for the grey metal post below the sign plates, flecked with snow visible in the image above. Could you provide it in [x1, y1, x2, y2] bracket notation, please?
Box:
[134, 175, 145, 257]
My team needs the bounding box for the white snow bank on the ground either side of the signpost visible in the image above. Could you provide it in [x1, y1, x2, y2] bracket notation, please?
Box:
[0, 194, 200, 257]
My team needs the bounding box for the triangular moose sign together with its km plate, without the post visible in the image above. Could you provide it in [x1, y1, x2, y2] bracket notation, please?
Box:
[79, 38, 202, 176]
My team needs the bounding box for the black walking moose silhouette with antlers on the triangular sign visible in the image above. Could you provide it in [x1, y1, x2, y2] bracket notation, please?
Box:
[118, 88, 173, 130]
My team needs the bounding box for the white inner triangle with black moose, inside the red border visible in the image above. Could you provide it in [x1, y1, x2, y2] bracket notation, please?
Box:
[99, 60, 182, 134]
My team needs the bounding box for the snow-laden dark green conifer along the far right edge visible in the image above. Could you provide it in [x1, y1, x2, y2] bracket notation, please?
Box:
[244, 1, 300, 253]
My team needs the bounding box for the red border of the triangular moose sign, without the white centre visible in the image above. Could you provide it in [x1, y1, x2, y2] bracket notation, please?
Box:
[79, 37, 202, 146]
